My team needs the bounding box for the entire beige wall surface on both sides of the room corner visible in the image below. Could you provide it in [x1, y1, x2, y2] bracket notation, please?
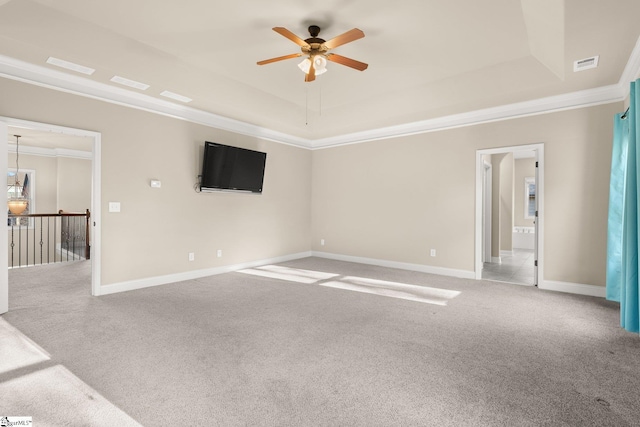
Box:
[0, 79, 623, 285]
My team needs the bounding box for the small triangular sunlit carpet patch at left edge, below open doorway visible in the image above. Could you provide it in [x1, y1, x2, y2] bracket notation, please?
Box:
[0, 318, 50, 374]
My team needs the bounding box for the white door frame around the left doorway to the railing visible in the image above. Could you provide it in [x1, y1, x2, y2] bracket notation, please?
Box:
[0, 116, 102, 314]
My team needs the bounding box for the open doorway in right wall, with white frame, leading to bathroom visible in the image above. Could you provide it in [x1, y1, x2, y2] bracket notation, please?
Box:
[475, 144, 544, 286]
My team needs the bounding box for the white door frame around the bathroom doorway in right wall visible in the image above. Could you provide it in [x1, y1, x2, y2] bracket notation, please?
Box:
[475, 143, 544, 286]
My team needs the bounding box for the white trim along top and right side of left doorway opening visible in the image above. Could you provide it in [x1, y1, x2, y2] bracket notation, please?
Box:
[0, 116, 102, 300]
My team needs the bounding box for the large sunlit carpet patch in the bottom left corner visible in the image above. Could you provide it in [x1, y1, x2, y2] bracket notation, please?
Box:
[0, 365, 140, 426]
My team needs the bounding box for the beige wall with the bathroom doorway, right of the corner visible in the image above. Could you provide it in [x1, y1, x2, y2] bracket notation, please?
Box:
[312, 103, 622, 285]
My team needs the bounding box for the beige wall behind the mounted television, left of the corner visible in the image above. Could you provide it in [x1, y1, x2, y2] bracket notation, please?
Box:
[0, 79, 311, 285]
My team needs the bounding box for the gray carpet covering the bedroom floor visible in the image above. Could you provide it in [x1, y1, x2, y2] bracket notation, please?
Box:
[0, 258, 640, 426]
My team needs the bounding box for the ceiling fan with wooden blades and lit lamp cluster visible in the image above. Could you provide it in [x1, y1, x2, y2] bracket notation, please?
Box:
[258, 25, 369, 82]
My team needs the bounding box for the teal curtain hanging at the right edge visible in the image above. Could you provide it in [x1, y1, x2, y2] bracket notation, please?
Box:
[607, 79, 640, 333]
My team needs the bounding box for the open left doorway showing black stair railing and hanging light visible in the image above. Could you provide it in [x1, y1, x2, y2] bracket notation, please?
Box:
[6, 126, 93, 280]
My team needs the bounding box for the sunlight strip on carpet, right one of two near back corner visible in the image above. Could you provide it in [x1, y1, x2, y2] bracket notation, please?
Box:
[320, 276, 461, 305]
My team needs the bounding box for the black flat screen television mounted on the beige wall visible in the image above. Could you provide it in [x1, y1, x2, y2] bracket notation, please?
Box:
[200, 141, 267, 193]
